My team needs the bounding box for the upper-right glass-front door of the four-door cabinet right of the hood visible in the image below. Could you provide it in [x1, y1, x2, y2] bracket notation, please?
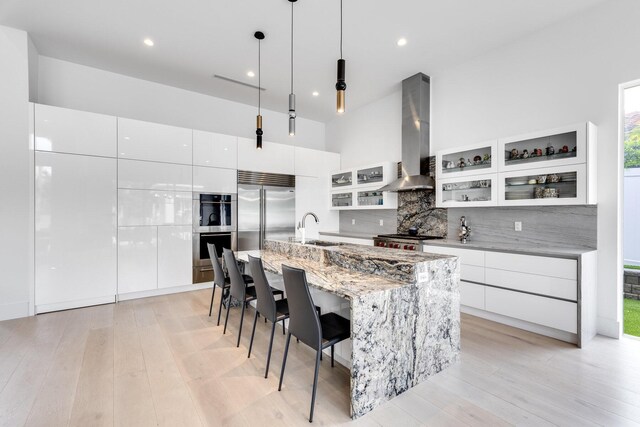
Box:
[498, 122, 595, 172]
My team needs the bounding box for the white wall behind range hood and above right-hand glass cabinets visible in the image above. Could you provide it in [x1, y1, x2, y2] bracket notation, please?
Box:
[327, 0, 640, 336]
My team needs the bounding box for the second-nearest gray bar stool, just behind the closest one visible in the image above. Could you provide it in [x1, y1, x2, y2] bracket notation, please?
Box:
[247, 255, 289, 378]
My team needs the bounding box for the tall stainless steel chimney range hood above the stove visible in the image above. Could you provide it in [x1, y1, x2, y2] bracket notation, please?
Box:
[380, 73, 435, 191]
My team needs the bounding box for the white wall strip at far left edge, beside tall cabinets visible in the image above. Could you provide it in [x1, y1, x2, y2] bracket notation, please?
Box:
[0, 26, 33, 320]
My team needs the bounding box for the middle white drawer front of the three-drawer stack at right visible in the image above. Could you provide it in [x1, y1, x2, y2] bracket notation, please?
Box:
[484, 268, 578, 301]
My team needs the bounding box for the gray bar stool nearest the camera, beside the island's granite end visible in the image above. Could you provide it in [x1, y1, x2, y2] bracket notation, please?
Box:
[278, 265, 351, 422]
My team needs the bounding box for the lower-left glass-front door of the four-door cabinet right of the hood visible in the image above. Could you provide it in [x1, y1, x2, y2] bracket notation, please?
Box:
[436, 174, 498, 208]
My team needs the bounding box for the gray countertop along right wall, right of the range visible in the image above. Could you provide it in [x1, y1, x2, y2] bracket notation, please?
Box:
[427, 239, 596, 259]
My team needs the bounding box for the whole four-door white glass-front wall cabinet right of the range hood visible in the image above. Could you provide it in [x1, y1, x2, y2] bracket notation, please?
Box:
[436, 122, 597, 207]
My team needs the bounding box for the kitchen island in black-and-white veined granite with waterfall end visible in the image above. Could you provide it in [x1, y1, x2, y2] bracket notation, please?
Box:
[238, 241, 460, 418]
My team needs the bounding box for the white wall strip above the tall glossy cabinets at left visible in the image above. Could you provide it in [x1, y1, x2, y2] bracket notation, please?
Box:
[35, 56, 325, 150]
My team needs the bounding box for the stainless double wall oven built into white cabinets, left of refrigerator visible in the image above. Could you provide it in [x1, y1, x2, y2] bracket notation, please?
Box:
[193, 193, 238, 283]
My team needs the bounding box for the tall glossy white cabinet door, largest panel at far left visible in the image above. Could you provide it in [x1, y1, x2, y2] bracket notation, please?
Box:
[35, 152, 117, 313]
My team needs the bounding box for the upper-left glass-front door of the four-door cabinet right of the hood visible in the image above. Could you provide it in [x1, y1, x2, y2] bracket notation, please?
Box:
[436, 140, 498, 179]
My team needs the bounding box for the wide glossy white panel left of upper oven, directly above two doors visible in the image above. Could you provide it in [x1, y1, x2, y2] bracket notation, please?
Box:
[118, 189, 193, 227]
